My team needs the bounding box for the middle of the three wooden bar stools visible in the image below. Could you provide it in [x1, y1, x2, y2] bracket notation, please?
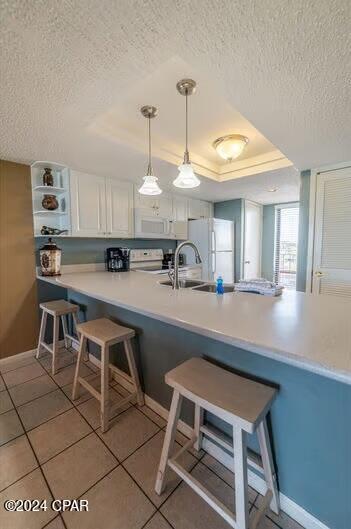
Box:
[72, 318, 144, 432]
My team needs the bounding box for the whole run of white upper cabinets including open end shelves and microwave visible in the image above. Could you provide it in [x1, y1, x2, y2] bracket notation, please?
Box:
[31, 162, 212, 240]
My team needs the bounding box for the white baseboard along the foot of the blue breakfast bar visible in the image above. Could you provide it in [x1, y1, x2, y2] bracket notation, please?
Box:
[69, 346, 329, 529]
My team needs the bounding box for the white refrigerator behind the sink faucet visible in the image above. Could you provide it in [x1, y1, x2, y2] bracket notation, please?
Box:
[184, 219, 234, 283]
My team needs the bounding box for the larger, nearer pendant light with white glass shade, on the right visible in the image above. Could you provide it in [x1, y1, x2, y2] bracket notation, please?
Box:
[173, 79, 200, 189]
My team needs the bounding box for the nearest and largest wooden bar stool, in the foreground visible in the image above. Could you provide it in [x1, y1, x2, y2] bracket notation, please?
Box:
[155, 358, 279, 529]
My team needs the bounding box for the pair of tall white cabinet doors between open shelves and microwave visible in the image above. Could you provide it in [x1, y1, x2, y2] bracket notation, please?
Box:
[70, 171, 133, 237]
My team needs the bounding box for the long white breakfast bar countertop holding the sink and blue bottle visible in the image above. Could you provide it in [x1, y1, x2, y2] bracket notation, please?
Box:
[39, 272, 351, 384]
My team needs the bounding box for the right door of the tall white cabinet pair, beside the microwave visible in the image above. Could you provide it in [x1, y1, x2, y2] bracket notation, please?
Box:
[106, 178, 133, 237]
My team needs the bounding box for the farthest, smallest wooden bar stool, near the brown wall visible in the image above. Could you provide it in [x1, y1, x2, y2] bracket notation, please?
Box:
[36, 299, 79, 375]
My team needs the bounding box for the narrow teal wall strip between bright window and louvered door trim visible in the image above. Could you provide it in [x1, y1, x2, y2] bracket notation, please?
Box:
[296, 170, 311, 292]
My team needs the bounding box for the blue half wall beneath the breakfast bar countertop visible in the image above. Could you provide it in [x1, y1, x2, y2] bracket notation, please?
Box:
[39, 282, 351, 529]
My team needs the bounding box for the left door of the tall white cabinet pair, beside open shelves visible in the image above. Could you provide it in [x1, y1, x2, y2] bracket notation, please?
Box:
[70, 171, 107, 237]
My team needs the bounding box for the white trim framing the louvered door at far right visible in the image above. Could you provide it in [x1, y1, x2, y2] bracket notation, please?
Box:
[306, 161, 351, 293]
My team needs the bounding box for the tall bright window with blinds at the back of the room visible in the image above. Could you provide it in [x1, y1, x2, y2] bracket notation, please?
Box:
[274, 204, 299, 290]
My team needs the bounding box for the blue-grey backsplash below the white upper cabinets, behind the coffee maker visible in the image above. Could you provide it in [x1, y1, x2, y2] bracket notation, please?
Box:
[35, 237, 177, 265]
